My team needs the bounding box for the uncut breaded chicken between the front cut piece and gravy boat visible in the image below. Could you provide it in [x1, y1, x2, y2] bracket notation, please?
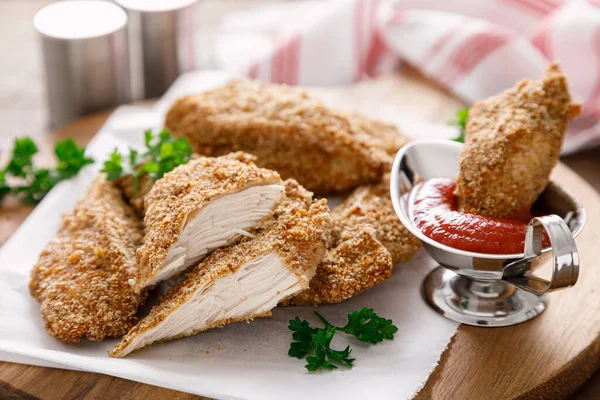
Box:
[286, 175, 420, 305]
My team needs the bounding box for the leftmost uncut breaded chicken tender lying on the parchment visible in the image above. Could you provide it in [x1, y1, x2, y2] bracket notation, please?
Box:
[29, 176, 145, 343]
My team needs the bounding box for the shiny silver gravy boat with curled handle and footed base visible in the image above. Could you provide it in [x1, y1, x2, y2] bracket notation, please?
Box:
[390, 140, 586, 327]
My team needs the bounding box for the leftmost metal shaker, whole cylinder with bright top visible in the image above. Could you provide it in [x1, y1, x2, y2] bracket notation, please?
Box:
[34, 0, 131, 126]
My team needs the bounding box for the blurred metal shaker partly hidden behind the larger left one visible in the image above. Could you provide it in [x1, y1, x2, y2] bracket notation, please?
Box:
[115, 0, 197, 99]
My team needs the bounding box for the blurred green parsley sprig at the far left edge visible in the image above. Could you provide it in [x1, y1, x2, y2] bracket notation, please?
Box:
[0, 137, 94, 204]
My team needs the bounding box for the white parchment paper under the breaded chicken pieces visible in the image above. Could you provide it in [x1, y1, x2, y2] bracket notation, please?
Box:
[0, 73, 457, 399]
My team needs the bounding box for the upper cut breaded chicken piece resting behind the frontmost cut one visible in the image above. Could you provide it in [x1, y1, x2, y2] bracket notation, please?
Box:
[137, 153, 285, 288]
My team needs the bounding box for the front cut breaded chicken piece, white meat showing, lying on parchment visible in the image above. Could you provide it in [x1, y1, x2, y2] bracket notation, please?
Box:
[111, 180, 331, 357]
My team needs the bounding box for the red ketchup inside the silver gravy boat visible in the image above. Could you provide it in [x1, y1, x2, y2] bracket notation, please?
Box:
[412, 178, 547, 254]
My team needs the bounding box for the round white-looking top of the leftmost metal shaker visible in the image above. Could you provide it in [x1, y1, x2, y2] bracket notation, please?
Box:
[33, 0, 127, 40]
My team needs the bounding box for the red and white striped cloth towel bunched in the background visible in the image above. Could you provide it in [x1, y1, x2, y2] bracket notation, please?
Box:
[217, 0, 600, 152]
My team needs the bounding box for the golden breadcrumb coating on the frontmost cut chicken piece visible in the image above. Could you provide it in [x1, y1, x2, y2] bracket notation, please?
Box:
[110, 180, 332, 357]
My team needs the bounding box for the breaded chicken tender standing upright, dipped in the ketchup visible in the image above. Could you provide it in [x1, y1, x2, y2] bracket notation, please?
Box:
[456, 64, 580, 218]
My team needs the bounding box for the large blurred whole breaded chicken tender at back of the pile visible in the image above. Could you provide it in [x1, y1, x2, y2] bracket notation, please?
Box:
[165, 79, 404, 195]
